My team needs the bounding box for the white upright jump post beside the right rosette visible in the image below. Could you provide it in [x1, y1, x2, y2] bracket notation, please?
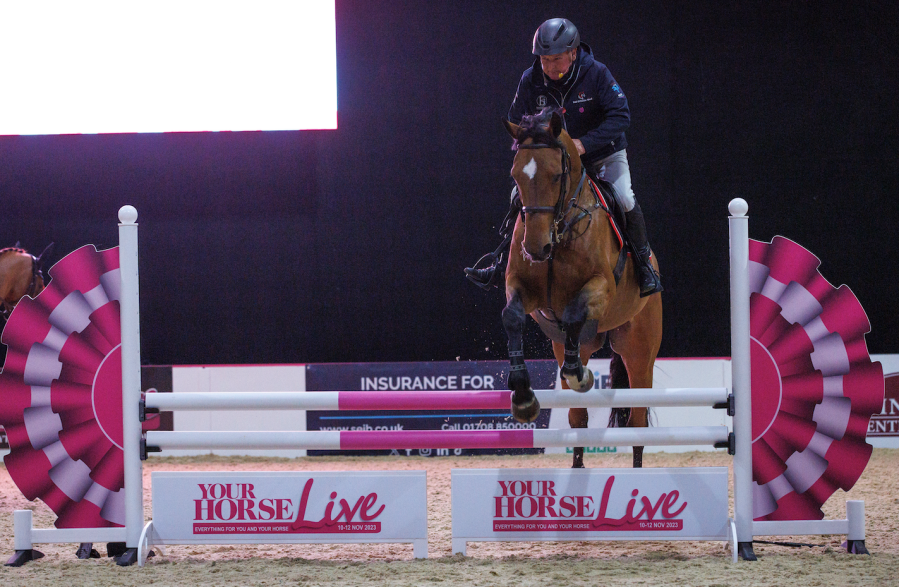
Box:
[728, 198, 755, 560]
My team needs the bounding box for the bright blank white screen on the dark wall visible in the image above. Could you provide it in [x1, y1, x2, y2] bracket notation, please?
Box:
[0, 0, 337, 135]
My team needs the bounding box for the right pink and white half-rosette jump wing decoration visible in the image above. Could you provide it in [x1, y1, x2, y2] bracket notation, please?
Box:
[749, 236, 884, 520]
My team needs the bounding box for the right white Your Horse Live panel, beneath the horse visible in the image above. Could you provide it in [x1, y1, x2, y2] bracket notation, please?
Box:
[452, 467, 728, 551]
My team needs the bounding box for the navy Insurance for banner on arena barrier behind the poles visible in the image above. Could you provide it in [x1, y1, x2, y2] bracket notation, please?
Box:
[306, 360, 558, 457]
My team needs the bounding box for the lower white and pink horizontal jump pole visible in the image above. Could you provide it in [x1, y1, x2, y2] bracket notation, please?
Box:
[146, 426, 728, 452]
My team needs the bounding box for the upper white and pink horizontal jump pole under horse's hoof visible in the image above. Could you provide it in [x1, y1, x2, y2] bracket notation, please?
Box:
[144, 387, 728, 413]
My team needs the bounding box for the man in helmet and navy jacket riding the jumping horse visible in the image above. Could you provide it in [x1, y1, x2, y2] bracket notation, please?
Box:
[465, 18, 662, 297]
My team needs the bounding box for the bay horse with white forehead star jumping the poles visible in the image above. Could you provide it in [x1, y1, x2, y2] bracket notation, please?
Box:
[502, 109, 662, 468]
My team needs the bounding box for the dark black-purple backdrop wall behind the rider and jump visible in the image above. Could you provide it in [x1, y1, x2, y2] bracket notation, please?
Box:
[0, 0, 899, 364]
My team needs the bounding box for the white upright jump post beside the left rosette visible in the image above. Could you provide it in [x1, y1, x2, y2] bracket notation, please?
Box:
[116, 206, 144, 566]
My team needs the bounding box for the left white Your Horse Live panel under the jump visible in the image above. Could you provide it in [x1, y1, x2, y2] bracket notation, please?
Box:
[152, 471, 427, 544]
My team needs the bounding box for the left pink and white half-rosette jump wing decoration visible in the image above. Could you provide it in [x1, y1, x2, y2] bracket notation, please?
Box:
[0, 245, 158, 528]
